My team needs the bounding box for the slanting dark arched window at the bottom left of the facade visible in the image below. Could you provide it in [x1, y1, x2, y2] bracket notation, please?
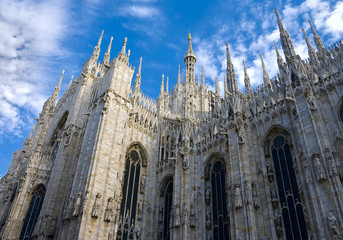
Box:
[20, 185, 45, 240]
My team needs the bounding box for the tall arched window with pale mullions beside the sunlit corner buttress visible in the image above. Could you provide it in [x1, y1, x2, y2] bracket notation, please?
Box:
[117, 150, 141, 240]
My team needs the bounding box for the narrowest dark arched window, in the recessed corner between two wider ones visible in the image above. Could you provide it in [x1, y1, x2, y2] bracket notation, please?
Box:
[162, 181, 173, 240]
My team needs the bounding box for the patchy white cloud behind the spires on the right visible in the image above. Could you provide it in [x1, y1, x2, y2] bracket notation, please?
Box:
[194, 0, 343, 95]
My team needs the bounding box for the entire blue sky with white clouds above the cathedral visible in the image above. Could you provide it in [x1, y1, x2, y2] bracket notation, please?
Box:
[0, 0, 343, 176]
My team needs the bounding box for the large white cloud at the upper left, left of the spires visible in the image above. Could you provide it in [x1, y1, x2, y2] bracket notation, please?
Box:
[0, 0, 68, 140]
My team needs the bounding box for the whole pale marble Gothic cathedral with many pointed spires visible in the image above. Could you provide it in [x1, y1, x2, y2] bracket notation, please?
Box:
[0, 10, 343, 240]
